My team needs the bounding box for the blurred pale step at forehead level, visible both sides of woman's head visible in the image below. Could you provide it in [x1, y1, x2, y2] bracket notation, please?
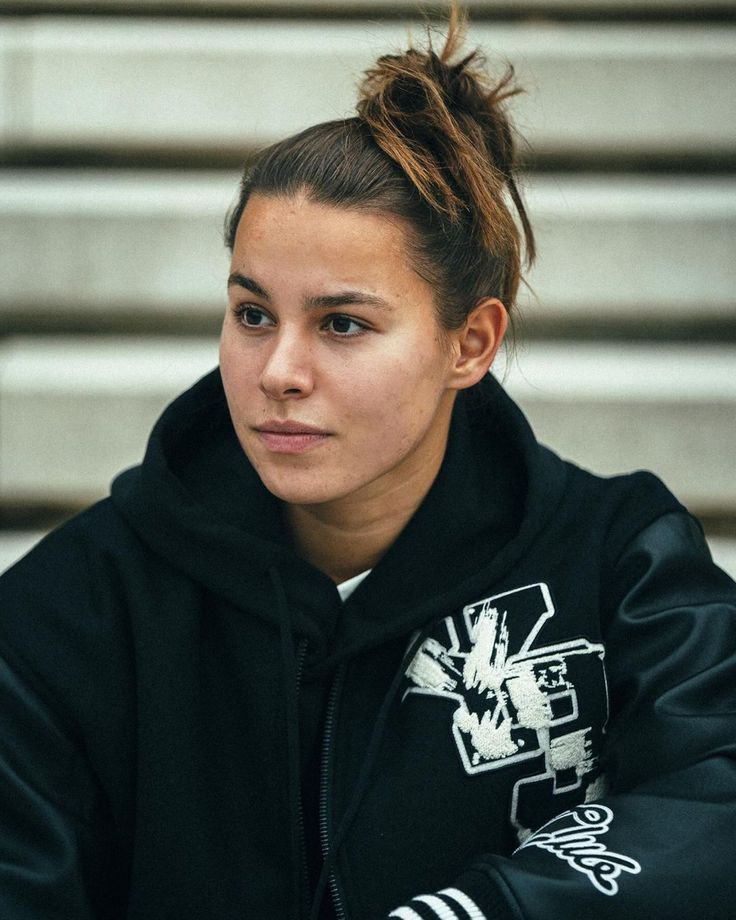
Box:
[0, 170, 736, 337]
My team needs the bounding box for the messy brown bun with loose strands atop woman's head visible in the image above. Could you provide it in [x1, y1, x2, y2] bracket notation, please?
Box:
[357, 3, 534, 261]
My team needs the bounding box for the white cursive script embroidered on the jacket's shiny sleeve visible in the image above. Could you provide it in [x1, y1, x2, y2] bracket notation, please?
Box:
[516, 805, 641, 895]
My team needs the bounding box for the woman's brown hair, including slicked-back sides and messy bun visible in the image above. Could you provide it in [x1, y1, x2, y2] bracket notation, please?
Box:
[225, 2, 534, 329]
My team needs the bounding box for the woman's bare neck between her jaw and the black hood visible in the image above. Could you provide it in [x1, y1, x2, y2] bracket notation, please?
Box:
[286, 416, 447, 584]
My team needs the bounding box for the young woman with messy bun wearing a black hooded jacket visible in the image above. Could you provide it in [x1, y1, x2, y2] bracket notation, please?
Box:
[0, 7, 736, 920]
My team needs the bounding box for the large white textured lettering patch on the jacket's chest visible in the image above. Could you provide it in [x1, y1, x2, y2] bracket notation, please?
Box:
[404, 583, 608, 841]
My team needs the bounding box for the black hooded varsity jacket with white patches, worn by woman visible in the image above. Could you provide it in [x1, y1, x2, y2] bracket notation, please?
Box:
[0, 372, 736, 920]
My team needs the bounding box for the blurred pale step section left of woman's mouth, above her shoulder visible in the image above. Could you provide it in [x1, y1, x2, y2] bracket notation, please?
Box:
[0, 337, 217, 506]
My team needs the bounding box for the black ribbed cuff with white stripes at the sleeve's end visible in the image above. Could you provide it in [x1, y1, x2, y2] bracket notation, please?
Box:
[389, 869, 521, 920]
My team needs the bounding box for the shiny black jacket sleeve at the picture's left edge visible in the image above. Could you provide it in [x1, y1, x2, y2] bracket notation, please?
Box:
[0, 524, 120, 920]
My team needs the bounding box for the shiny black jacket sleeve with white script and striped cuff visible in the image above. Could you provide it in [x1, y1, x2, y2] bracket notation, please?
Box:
[390, 512, 736, 920]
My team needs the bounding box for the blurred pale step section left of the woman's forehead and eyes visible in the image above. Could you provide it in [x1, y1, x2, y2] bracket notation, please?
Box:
[0, 169, 234, 328]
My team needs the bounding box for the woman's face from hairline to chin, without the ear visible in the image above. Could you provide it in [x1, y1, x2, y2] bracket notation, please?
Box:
[220, 194, 466, 505]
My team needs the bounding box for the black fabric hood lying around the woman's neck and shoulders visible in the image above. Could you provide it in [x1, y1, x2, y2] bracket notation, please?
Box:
[112, 370, 565, 659]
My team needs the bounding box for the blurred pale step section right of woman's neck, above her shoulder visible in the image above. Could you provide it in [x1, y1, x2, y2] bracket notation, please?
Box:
[507, 342, 736, 517]
